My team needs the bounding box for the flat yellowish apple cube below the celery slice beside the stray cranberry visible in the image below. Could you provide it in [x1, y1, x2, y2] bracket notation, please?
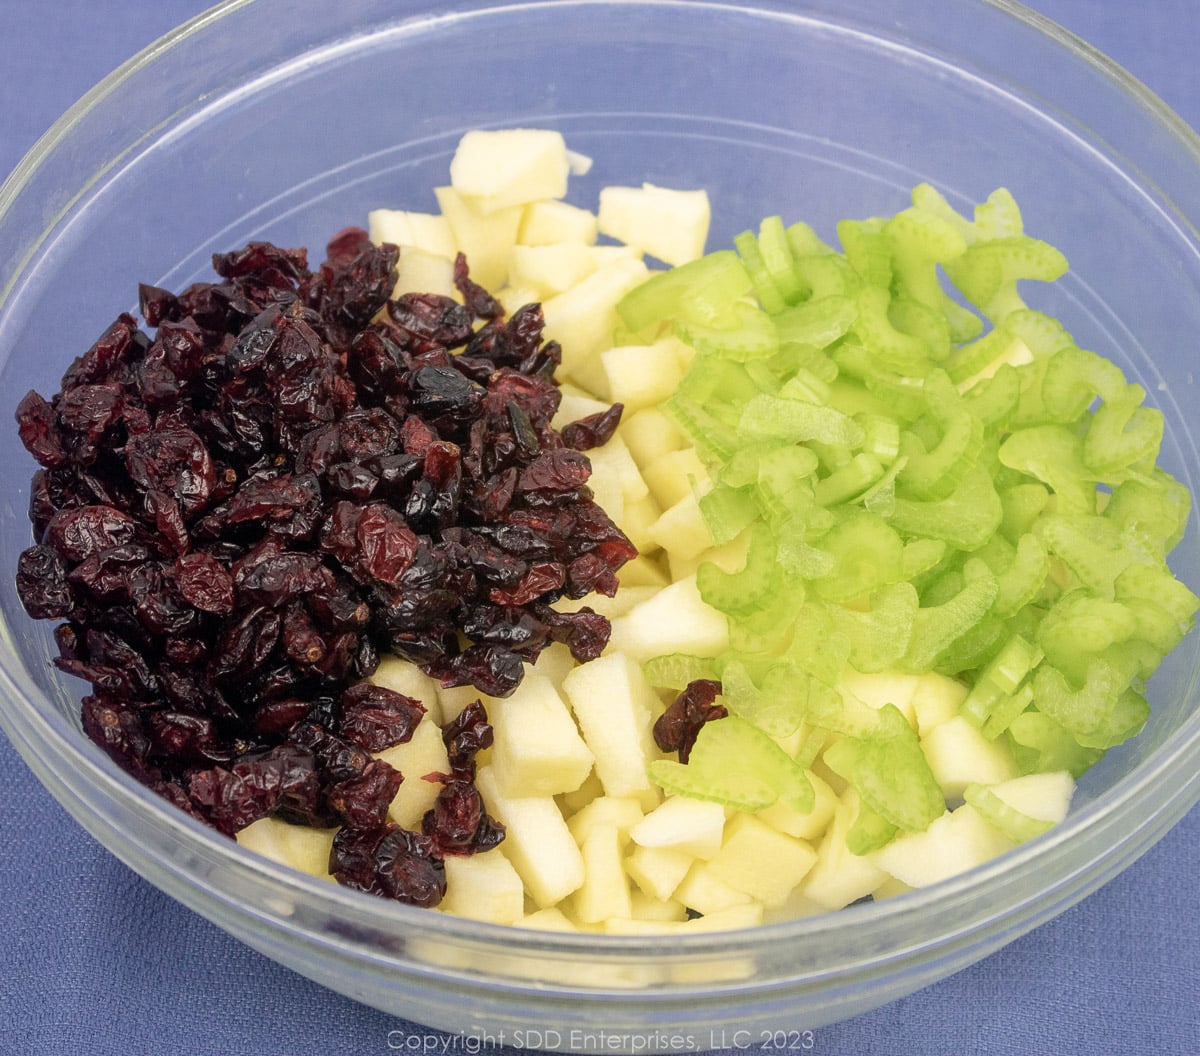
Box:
[708, 814, 817, 908]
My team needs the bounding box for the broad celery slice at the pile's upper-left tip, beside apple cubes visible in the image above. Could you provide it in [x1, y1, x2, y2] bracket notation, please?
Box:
[617, 250, 751, 334]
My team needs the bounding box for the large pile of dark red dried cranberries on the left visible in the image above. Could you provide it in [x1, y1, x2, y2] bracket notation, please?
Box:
[17, 228, 635, 905]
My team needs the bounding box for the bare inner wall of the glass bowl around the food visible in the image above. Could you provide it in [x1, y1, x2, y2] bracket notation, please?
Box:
[0, 0, 1200, 1041]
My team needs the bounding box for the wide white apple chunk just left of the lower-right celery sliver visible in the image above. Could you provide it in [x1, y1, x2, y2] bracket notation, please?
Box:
[869, 803, 1016, 887]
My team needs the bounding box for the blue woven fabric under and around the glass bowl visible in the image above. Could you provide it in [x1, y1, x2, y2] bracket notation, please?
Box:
[0, 0, 1200, 1056]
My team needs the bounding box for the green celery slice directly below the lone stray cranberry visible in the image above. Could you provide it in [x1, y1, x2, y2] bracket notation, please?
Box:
[649, 715, 815, 814]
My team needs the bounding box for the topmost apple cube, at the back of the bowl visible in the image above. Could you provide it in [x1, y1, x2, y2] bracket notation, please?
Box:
[450, 128, 570, 214]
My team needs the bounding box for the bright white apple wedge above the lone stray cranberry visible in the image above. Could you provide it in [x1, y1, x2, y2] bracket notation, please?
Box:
[610, 576, 730, 662]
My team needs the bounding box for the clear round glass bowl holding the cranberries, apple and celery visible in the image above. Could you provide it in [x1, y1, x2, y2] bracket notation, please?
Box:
[0, 0, 1200, 1051]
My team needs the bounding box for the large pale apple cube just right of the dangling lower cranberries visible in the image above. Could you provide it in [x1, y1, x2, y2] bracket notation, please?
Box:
[488, 674, 593, 797]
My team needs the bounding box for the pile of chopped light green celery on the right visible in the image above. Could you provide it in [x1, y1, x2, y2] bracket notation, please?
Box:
[618, 185, 1200, 853]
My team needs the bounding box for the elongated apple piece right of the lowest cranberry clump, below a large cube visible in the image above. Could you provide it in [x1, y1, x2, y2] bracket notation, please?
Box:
[475, 767, 584, 908]
